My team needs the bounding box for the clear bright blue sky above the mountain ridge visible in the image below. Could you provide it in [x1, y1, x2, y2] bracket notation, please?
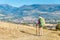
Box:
[0, 0, 60, 7]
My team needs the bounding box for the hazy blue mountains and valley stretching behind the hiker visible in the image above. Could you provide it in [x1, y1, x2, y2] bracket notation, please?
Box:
[0, 4, 60, 23]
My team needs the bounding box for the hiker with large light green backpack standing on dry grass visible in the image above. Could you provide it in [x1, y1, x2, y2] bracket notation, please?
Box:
[36, 17, 45, 35]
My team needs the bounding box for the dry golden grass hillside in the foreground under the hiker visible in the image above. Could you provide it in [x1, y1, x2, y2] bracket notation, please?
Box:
[0, 21, 60, 40]
